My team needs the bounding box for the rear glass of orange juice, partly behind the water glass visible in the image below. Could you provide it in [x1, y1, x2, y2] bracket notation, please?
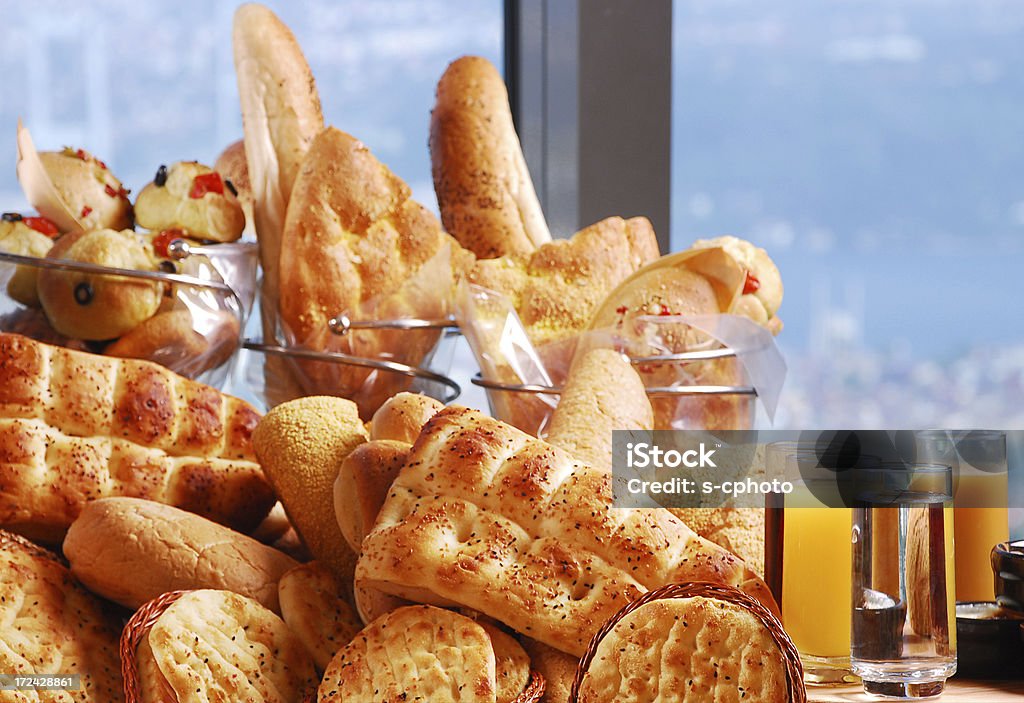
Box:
[914, 430, 1010, 601]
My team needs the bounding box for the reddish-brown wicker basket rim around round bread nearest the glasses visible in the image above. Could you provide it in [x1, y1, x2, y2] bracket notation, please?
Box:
[569, 581, 807, 703]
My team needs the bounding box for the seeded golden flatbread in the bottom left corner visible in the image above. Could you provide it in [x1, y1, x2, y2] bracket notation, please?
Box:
[0, 530, 124, 703]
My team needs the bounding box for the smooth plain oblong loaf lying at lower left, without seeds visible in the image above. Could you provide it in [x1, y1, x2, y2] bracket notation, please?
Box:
[63, 497, 297, 612]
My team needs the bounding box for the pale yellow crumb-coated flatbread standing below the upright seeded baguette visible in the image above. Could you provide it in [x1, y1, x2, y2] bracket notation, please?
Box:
[468, 217, 657, 354]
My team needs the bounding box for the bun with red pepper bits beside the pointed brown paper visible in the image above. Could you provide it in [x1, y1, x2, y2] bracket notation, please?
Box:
[39, 146, 132, 230]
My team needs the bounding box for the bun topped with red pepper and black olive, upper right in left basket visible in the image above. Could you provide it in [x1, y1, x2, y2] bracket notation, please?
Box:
[135, 161, 246, 241]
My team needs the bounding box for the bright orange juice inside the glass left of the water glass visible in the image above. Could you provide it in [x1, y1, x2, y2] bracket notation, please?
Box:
[781, 507, 853, 657]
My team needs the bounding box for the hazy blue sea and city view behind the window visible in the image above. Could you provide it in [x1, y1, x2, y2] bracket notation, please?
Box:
[0, 0, 1024, 528]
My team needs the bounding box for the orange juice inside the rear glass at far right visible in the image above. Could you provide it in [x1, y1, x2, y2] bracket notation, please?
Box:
[953, 471, 1010, 601]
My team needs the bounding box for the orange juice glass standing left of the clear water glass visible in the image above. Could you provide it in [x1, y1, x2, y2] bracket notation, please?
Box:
[765, 442, 858, 685]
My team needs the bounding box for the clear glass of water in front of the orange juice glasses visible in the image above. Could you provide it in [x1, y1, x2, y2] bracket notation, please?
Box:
[844, 464, 956, 698]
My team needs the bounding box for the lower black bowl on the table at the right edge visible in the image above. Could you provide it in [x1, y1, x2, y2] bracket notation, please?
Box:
[956, 601, 1024, 678]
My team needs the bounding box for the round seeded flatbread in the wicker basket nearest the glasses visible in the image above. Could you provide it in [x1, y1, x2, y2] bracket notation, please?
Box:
[579, 597, 790, 703]
